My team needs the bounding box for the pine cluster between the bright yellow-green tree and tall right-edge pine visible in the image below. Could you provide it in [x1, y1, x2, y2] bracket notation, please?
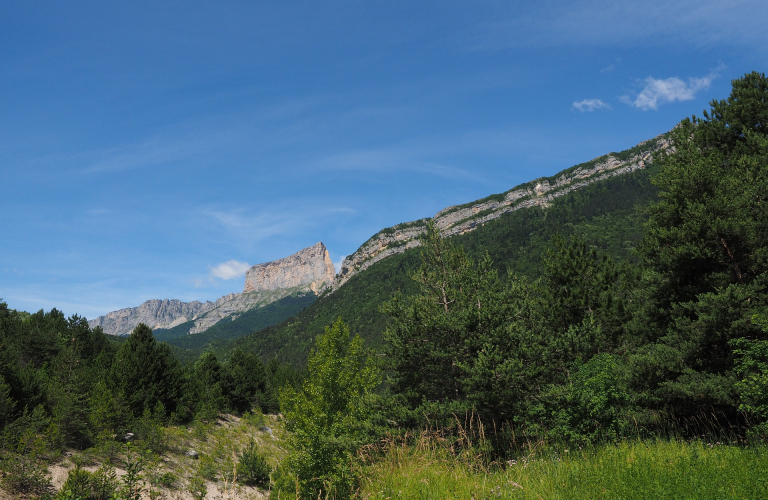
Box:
[383, 225, 632, 430]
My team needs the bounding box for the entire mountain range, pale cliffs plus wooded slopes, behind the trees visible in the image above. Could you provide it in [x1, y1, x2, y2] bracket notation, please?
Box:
[92, 134, 669, 365]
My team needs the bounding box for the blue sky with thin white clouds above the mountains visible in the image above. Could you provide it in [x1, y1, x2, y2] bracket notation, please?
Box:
[0, 0, 768, 318]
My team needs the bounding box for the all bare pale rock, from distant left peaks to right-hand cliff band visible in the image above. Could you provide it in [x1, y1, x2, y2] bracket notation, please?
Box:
[89, 133, 670, 342]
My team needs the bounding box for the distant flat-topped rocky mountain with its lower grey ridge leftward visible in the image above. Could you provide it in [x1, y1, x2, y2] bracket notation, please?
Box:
[88, 242, 334, 336]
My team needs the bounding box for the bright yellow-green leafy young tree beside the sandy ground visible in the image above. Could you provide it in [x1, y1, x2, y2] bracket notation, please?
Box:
[280, 318, 381, 499]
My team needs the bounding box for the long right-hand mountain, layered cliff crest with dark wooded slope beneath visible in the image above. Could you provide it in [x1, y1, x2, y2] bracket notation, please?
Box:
[216, 134, 669, 366]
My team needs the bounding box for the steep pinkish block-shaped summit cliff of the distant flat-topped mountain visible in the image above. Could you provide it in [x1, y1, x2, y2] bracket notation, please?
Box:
[243, 243, 336, 293]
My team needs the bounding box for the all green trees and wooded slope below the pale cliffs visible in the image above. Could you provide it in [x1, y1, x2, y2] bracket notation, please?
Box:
[0, 73, 768, 499]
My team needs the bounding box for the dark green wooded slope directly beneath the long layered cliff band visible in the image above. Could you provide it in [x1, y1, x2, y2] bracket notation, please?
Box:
[222, 162, 656, 366]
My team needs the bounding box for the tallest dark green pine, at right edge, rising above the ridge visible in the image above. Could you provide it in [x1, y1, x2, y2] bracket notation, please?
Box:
[633, 73, 768, 417]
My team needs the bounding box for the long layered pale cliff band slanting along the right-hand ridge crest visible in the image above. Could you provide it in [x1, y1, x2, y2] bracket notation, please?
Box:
[334, 134, 670, 288]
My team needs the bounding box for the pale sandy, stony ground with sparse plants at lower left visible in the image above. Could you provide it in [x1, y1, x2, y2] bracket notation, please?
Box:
[26, 415, 286, 500]
